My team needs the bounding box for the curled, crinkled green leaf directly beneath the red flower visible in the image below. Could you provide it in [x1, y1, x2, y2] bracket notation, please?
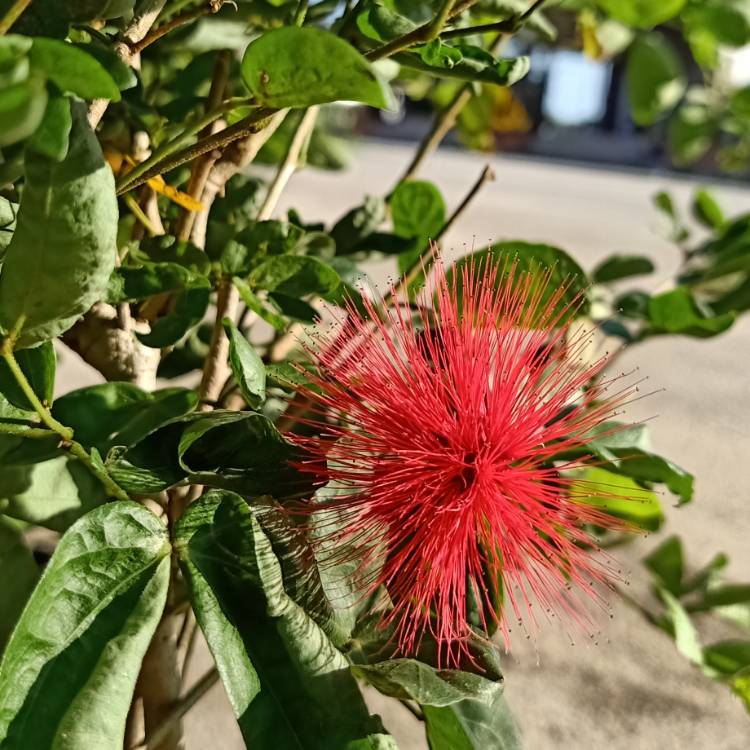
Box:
[351, 659, 503, 707]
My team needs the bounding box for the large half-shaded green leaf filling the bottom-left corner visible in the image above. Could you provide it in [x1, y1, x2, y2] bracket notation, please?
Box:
[0, 502, 170, 750]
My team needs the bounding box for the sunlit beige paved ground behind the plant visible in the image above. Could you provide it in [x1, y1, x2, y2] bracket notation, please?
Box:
[60, 144, 750, 750]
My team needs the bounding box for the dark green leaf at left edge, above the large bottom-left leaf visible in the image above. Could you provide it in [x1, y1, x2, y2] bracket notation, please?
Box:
[0, 516, 39, 653]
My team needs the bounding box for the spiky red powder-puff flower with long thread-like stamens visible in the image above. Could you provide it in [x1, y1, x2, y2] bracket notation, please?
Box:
[294, 264, 631, 663]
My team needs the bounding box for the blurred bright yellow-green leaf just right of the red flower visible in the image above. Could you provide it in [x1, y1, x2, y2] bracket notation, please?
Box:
[571, 468, 664, 531]
